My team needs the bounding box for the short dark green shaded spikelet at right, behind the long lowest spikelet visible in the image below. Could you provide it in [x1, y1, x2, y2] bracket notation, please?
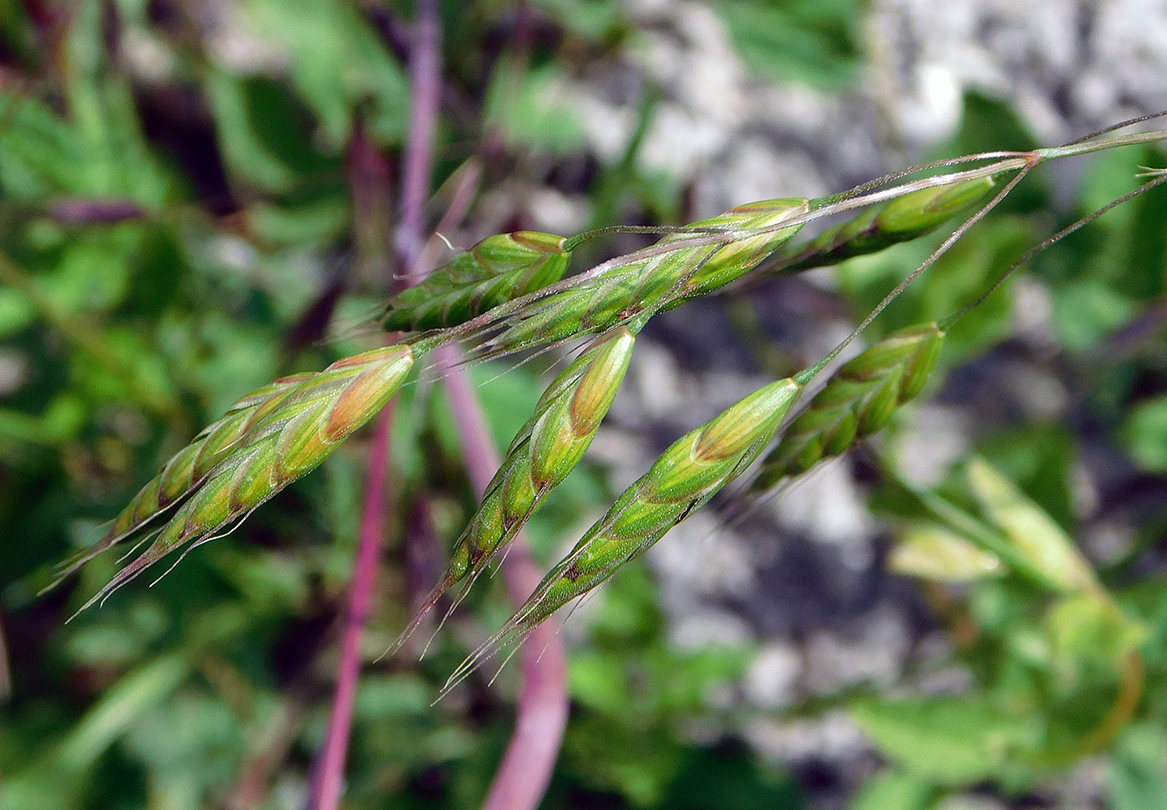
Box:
[752, 323, 945, 491]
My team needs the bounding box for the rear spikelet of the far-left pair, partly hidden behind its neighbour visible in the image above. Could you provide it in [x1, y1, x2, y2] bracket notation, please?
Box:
[49, 372, 314, 587]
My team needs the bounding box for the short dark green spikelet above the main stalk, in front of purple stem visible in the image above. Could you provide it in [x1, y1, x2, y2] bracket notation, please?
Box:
[383, 231, 571, 331]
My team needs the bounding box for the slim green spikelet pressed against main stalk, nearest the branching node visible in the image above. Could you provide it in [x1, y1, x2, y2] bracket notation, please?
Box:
[777, 177, 995, 273]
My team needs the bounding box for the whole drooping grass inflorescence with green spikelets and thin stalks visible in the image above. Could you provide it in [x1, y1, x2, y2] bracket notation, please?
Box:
[56, 115, 1167, 689]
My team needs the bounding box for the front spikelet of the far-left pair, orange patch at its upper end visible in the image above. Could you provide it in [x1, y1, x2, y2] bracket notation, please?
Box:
[70, 345, 413, 610]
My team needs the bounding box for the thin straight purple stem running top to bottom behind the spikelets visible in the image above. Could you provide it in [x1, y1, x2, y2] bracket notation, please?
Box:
[309, 0, 440, 810]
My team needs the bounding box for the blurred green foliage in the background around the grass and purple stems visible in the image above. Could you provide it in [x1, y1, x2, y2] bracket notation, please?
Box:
[0, 0, 1167, 810]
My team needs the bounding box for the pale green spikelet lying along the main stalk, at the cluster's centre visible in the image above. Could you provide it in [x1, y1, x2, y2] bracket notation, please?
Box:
[484, 198, 809, 356]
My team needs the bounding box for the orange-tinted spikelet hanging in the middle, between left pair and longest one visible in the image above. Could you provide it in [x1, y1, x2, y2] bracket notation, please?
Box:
[390, 328, 636, 652]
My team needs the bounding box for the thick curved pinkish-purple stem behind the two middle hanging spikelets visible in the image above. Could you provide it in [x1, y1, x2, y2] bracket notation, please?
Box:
[435, 345, 567, 810]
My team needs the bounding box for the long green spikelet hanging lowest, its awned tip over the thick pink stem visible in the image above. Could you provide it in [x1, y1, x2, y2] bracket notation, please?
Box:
[446, 378, 803, 690]
